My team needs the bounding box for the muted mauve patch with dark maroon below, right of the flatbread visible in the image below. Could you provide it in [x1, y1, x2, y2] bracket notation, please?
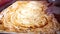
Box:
[47, 6, 60, 23]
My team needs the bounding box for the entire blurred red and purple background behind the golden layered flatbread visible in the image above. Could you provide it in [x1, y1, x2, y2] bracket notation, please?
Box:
[0, 0, 60, 23]
